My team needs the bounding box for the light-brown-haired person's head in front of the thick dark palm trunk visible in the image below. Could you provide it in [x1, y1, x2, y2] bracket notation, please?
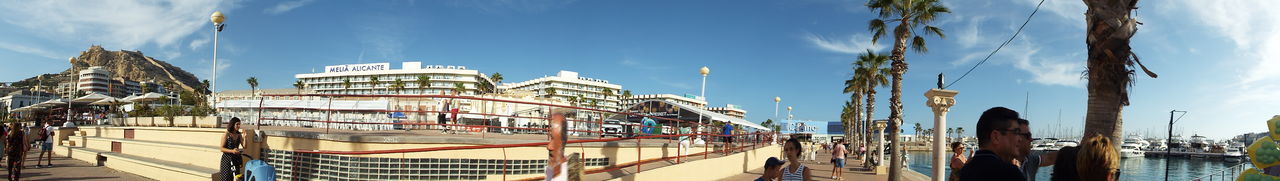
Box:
[1075, 135, 1120, 181]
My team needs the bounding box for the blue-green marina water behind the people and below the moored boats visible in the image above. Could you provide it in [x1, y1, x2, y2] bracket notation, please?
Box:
[906, 151, 1252, 181]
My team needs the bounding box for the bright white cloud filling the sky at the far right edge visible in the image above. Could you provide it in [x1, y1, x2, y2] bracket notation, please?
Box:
[1158, 0, 1280, 136]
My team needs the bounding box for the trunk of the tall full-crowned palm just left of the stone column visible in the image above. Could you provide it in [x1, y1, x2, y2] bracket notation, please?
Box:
[888, 20, 909, 181]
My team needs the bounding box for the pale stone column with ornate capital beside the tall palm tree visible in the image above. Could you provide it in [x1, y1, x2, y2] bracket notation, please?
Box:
[924, 89, 959, 181]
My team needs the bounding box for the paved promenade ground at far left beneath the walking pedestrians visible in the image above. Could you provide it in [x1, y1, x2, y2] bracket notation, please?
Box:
[20, 148, 151, 181]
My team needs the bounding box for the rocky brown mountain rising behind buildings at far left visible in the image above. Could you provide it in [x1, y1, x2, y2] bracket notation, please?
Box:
[13, 45, 200, 91]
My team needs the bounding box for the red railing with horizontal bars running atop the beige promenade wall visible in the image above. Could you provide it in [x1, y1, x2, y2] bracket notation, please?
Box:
[240, 94, 773, 180]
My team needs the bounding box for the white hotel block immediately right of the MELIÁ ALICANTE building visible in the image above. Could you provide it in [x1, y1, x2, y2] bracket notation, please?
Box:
[498, 71, 622, 110]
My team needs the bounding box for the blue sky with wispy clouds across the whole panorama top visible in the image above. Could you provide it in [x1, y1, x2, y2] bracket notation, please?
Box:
[0, 0, 1280, 139]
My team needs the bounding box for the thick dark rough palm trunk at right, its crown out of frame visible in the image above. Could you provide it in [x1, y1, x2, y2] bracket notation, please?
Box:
[1084, 0, 1157, 147]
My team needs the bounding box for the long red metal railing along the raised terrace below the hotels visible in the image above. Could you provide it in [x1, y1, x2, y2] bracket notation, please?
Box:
[240, 94, 774, 180]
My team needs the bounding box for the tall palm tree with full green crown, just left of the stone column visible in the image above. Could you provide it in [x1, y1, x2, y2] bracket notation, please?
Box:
[867, 0, 951, 177]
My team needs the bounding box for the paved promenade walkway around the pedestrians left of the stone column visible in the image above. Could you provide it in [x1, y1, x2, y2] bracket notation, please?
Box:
[722, 150, 929, 181]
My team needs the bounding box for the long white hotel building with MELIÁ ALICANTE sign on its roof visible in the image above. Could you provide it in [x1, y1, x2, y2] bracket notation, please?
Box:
[293, 62, 494, 96]
